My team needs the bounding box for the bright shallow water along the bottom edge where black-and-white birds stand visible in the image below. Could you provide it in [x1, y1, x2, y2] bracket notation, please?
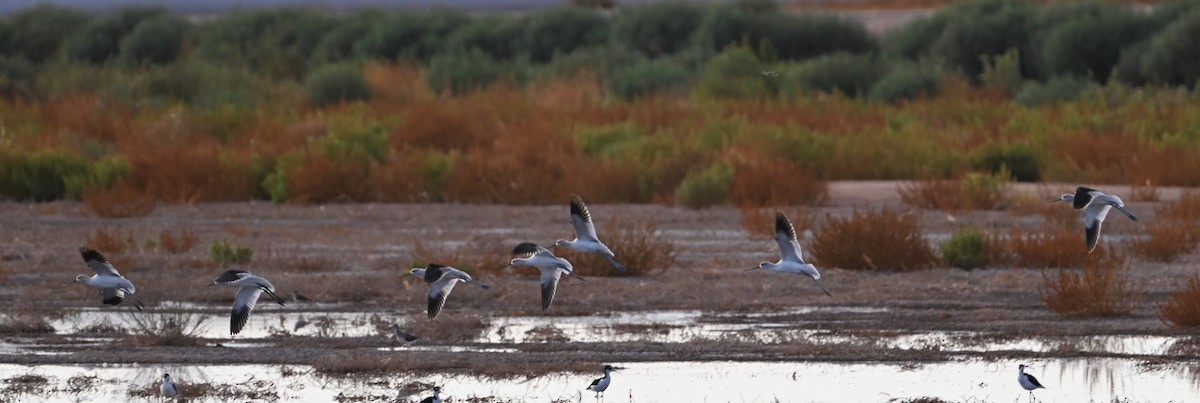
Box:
[0, 359, 1200, 403]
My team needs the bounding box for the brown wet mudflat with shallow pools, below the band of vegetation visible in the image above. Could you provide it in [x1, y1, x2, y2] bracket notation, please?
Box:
[0, 182, 1200, 402]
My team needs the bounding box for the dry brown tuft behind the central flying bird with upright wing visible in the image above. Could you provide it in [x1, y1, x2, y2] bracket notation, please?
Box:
[557, 218, 676, 277]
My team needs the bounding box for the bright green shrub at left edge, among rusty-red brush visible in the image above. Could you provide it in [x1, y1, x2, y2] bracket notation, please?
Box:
[0, 149, 90, 202]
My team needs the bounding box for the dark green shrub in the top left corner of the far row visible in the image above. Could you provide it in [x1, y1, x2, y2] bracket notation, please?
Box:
[7, 2, 89, 64]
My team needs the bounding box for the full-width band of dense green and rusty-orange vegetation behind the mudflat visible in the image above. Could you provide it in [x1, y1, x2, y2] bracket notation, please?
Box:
[0, 0, 1200, 206]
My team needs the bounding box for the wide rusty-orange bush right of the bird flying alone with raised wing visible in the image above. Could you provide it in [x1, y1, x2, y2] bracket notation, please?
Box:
[810, 209, 936, 271]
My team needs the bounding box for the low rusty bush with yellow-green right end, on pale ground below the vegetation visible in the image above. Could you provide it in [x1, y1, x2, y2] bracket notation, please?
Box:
[900, 173, 1007, 211]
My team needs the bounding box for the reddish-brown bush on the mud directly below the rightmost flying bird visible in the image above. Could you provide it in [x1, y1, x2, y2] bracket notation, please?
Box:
[1040, 248, 1141, 318]
